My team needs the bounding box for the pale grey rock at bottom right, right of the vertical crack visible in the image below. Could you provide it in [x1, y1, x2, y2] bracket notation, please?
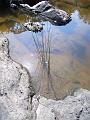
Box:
[33, 89, 90, 120]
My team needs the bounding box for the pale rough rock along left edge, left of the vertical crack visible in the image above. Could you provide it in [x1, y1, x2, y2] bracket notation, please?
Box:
[0, 37, 34, 120]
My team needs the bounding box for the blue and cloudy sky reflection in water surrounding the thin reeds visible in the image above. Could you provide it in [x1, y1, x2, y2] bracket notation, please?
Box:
[1, 7, 90, 99]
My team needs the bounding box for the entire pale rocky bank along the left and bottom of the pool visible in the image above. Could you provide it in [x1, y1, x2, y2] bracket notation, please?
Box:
[0, 37, 90, 120]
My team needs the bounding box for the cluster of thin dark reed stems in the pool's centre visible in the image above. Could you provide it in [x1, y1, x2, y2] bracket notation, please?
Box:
[32, 23, 57, 99]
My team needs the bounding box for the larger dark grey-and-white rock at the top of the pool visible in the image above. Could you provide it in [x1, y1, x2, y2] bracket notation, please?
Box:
[11, 1, 71, 25]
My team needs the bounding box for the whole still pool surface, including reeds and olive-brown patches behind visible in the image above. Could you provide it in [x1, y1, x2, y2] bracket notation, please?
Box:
[0, 2, 90, 99]
